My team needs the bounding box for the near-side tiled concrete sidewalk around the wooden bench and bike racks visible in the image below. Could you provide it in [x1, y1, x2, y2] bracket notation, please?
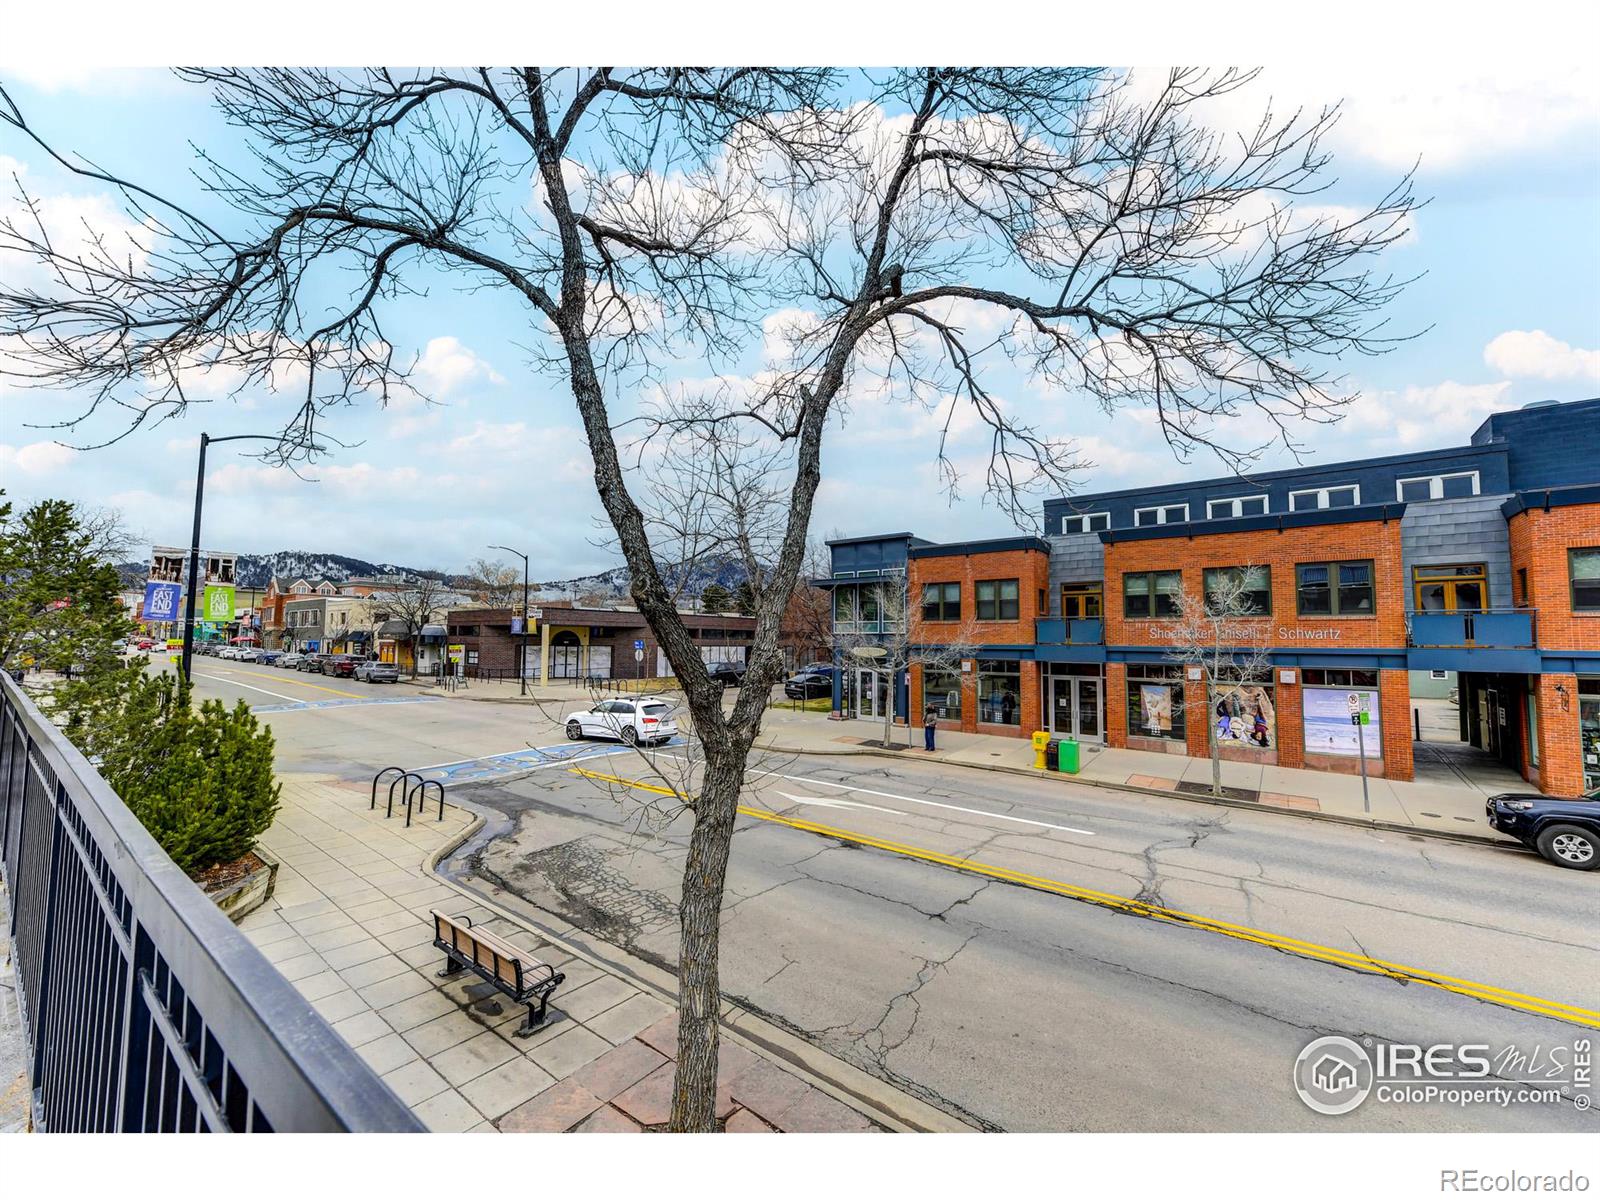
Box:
[242, 774, 965, 1133]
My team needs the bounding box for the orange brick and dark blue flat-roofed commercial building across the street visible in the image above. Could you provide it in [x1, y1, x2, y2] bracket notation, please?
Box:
[816, 400, 1600, 794]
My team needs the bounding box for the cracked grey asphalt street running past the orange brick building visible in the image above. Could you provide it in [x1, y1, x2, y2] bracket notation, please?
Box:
[178, 661, 1600, 1130]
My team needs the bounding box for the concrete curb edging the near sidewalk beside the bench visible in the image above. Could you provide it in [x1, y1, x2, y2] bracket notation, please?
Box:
[422, 800, 978, 1133]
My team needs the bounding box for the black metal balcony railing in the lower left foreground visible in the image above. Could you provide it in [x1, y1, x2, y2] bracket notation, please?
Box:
[0, 677, 421, 1133]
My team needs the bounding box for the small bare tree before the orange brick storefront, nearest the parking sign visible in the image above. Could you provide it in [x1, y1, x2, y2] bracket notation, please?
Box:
[1155, 566, 1277, 795]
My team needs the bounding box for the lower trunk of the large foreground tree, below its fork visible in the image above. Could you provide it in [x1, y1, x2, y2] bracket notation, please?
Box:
[670, 738, 750, 1133]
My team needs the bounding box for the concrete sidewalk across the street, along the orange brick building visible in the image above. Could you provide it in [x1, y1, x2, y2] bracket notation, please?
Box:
[758, 707, 1504, 843]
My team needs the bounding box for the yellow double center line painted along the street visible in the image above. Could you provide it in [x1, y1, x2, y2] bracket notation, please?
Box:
[571, 766, 1600, 1029]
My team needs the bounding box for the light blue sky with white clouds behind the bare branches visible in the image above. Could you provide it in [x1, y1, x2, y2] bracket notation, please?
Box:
[0, 62, 1600, 579]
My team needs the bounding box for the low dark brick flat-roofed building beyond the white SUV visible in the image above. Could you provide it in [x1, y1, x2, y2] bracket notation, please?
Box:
[445, 603, 755, 678]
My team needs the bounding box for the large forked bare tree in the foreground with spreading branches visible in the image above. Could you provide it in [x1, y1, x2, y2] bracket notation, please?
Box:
[0, 67, 1414, 1130]
